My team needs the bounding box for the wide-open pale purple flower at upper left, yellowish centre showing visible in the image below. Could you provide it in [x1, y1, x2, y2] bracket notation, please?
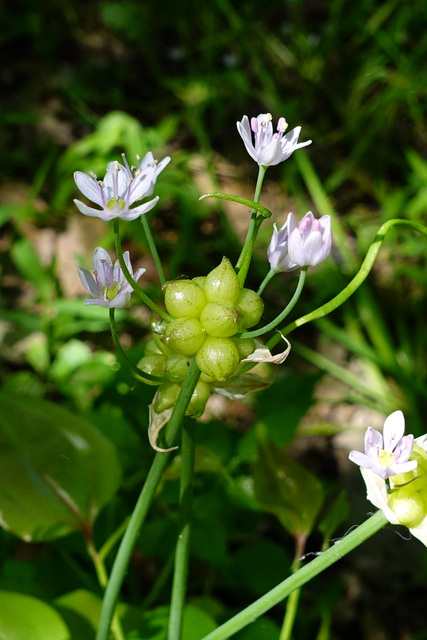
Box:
[74, 156, 161, 222]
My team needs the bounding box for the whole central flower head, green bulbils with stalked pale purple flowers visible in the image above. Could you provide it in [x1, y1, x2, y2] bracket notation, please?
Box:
[74, 114, 331, 451]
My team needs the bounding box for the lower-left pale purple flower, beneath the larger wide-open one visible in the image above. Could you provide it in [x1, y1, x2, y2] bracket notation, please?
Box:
[77, 247, 146, 309]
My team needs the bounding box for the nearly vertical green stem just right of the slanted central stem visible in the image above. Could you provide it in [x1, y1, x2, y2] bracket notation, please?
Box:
[168, 420, 196, 640]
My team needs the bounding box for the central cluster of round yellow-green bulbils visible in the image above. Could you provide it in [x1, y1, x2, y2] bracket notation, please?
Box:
[138, 257, 264, 417]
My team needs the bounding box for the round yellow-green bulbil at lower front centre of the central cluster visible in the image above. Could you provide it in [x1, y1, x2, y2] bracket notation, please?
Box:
[196, 336, 239, 380]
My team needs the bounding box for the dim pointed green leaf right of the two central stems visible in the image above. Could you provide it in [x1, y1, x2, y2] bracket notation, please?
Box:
[254, 441, 323, 537]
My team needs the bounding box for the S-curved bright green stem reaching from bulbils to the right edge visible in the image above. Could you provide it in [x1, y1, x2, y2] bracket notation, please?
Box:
[267, 218, 427, 349]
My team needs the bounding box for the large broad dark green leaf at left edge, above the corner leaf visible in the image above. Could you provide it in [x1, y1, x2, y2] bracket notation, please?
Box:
[0, 393, 120, 541]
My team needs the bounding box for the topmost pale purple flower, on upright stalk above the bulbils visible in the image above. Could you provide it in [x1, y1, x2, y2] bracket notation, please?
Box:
[236, 113, 311, 167]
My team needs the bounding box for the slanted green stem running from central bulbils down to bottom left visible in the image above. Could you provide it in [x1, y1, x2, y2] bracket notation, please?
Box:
[96, 359, 200, 640]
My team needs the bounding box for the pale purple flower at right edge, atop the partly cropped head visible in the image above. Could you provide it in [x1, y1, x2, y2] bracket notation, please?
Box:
[348, 411, 417, 480]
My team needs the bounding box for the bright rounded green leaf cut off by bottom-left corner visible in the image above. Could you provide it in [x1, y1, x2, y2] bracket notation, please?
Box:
[0, 591, 71, 640]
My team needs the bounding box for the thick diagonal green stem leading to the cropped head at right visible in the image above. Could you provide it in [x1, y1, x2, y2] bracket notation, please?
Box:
[202, 511, 388, 640]
